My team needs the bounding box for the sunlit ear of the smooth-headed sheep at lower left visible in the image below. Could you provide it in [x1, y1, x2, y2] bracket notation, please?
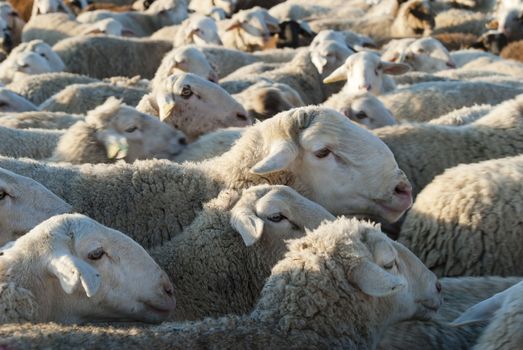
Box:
[48, 254, 101, 298]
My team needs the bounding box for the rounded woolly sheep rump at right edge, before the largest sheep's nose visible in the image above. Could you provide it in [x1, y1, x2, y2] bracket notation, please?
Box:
[399, 156, 523, 276]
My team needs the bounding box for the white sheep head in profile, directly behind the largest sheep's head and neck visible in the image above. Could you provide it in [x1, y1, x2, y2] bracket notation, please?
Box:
[151, 73, 253, 139]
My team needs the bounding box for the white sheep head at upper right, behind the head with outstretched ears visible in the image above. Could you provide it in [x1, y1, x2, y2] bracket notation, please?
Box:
[404, 38, 456, 73]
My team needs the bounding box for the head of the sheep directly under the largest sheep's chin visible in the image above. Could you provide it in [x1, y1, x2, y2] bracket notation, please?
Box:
[231, 185, 335, 247]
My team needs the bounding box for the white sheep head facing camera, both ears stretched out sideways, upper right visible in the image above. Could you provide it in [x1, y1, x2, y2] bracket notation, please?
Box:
[323, 52, 410, 95]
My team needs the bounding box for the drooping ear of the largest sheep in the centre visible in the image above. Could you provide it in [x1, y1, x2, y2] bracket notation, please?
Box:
[251, 141, 298, 175]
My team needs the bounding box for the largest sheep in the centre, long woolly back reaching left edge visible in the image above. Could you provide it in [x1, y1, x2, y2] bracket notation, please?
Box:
[0, 106, 412, 247]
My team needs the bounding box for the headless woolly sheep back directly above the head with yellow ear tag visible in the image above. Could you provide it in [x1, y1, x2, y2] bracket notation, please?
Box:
[39, 83, 147, 114]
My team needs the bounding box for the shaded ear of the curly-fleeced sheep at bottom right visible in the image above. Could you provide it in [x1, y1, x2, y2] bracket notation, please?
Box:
[349, 261, 407, 297]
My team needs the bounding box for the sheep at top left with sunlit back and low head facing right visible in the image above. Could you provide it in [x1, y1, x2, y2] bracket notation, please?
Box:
[22, 13, 132, 45]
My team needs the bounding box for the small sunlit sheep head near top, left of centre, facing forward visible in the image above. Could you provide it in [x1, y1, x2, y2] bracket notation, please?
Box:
[174, 15, 222, 47]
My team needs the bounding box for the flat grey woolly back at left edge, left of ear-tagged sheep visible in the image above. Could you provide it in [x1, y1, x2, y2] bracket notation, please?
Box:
[0, 126, 63, 159]
